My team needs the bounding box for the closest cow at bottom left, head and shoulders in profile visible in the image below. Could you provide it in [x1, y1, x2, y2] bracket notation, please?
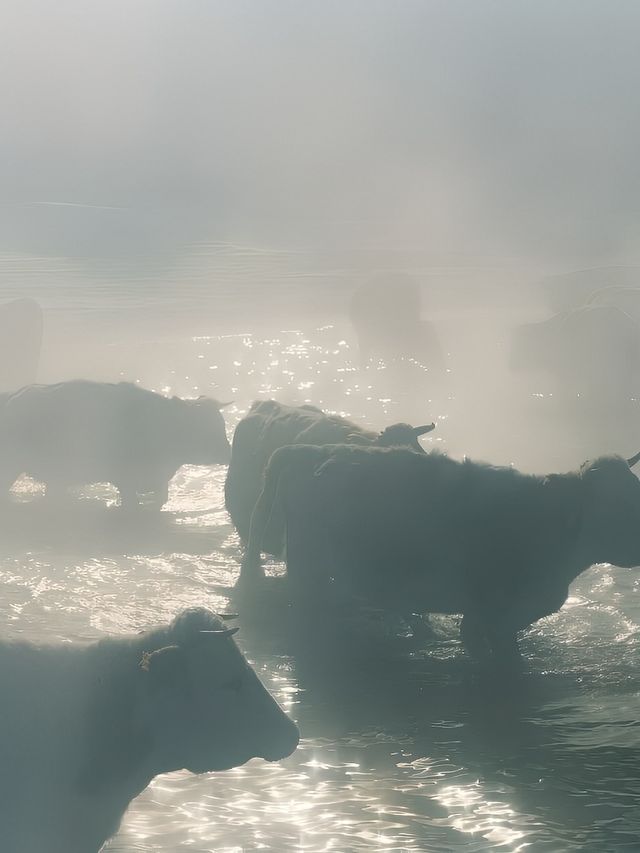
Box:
[0, 608, 299, 853]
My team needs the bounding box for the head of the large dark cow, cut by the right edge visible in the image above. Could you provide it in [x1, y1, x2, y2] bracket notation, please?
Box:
[580, 454, 640, 567]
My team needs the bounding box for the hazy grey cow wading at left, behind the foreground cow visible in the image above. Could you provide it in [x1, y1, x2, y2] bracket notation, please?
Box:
[0, 380, 231, 507]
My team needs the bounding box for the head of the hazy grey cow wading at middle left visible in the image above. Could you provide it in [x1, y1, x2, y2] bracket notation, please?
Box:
[174, 397, 231, 465]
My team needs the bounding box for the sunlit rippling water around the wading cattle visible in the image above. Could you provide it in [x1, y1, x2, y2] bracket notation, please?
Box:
[0, 250, 640, 853]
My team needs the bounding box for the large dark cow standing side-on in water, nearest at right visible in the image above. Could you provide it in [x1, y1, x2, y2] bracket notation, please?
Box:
[238, 445, 640, 663]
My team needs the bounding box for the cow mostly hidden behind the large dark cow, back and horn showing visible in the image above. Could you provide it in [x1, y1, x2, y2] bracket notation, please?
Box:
[225, 400, 435, 554]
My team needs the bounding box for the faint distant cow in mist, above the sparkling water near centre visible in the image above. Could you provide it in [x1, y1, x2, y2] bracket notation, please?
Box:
[349, 273, 443, 370]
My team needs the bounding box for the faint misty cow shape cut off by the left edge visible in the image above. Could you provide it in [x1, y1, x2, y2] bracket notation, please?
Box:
[0, 298, 42, 392]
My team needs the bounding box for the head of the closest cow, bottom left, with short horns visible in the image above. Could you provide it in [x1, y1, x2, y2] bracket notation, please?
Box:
[137, 609, 299, 773]
